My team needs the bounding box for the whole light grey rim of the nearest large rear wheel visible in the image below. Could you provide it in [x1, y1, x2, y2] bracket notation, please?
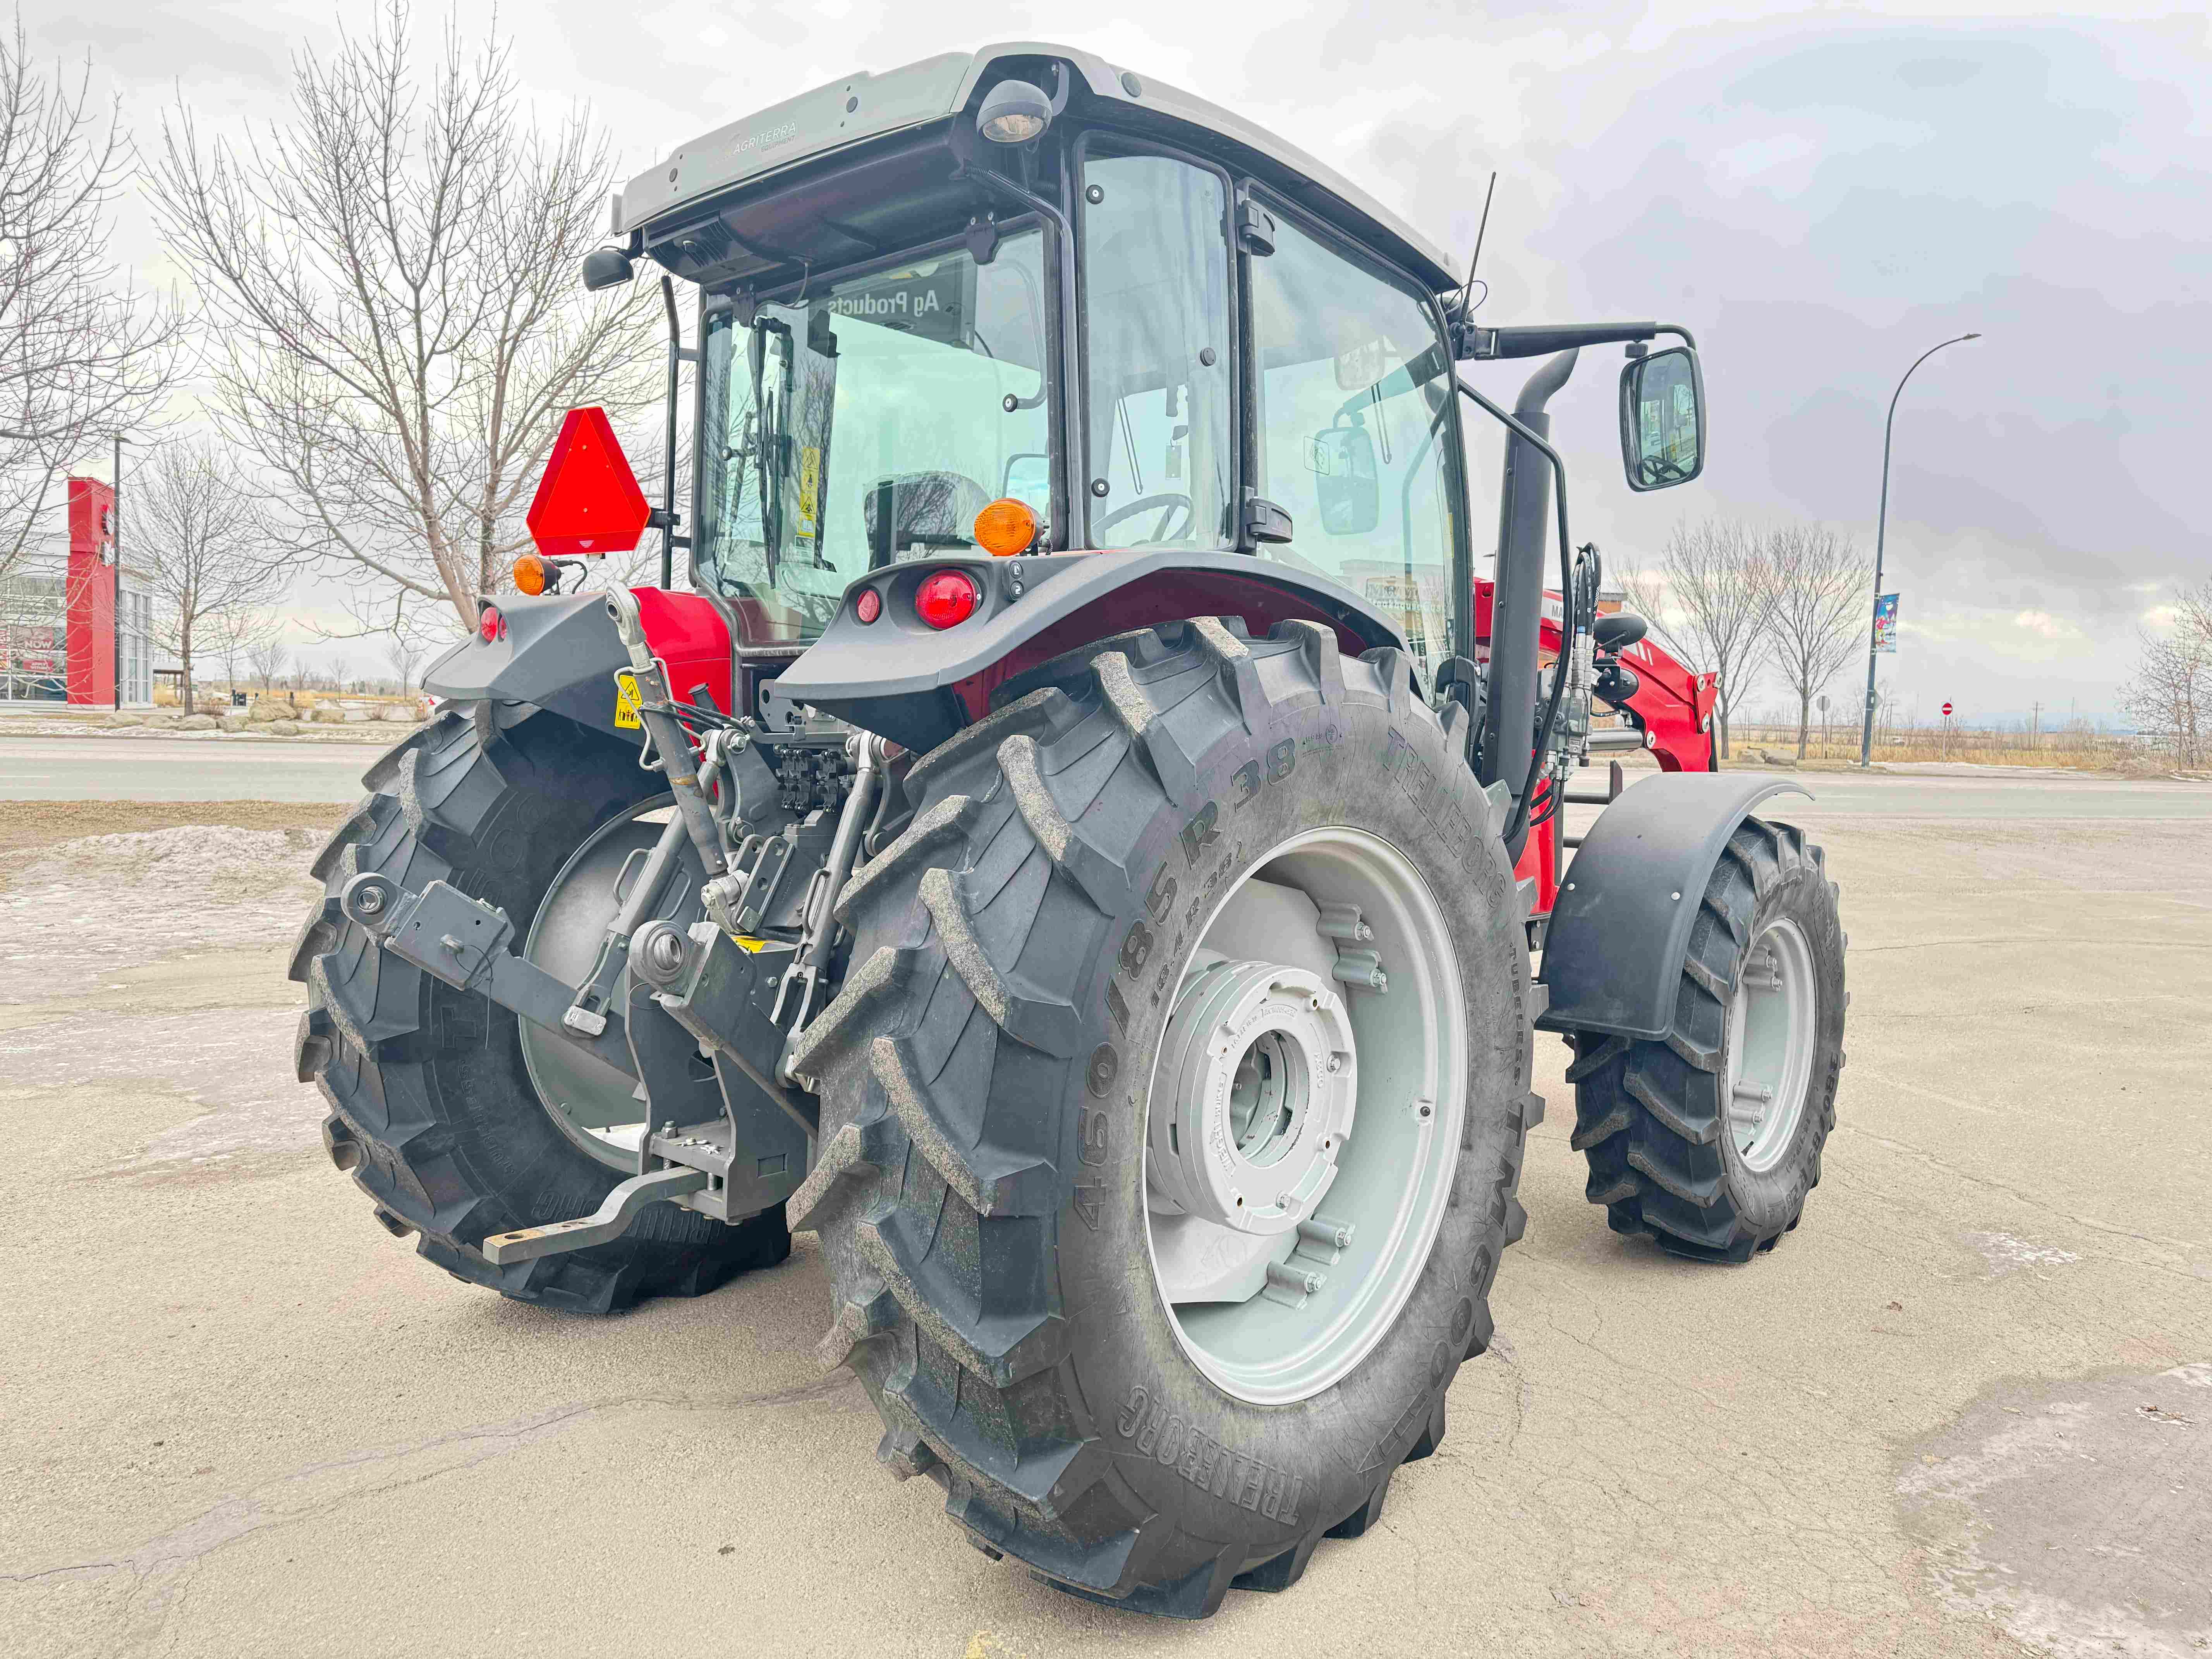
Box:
[1144, 827, 1467, 1405]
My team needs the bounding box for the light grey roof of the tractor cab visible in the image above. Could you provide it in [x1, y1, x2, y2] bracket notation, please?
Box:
[613, 40, 1458, 292]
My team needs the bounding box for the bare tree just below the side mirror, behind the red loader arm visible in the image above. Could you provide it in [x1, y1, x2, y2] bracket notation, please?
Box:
[1621, 518, 1774, 759]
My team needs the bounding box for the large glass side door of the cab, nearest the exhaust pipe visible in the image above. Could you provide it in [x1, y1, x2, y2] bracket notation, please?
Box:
[1248, 215, 1458, 675]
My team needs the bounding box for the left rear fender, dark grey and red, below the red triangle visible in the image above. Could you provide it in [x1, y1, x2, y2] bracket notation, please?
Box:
[422, 588, 732, 743]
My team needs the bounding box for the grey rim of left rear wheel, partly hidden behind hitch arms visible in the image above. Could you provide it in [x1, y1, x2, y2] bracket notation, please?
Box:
[520, 794, 675, 1175]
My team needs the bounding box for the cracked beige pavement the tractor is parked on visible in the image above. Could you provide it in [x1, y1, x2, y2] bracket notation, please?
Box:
[0, 774, 2212, 1659]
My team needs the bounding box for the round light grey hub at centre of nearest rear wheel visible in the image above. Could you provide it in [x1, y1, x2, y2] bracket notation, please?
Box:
[1148, 960, 1358, 1237]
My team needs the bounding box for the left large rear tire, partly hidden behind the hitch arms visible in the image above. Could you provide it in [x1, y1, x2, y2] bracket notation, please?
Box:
[290, 703, 790, 1314]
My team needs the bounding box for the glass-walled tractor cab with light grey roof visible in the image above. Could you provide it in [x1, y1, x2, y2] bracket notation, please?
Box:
[599, 44, 1469, 694]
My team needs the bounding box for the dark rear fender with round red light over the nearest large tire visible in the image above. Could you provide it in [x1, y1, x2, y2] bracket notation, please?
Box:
[774, 553, 1405, 754]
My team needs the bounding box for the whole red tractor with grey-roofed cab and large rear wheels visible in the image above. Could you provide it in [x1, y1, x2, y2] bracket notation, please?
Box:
[292, 44, 1845, 1617]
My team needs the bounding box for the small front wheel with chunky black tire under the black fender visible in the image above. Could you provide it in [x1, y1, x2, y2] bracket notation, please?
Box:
[1566, 818, 1847, 1261]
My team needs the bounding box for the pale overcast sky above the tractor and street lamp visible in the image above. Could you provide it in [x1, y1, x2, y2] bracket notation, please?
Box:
[22, 0, 2212, 719]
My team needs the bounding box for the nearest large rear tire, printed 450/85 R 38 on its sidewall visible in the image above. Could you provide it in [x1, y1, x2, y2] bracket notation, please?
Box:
[790, 619, 1542, 1617]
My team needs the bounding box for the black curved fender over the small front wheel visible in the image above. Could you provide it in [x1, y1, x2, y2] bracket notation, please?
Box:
[1537, 772, 1812, 1040]
